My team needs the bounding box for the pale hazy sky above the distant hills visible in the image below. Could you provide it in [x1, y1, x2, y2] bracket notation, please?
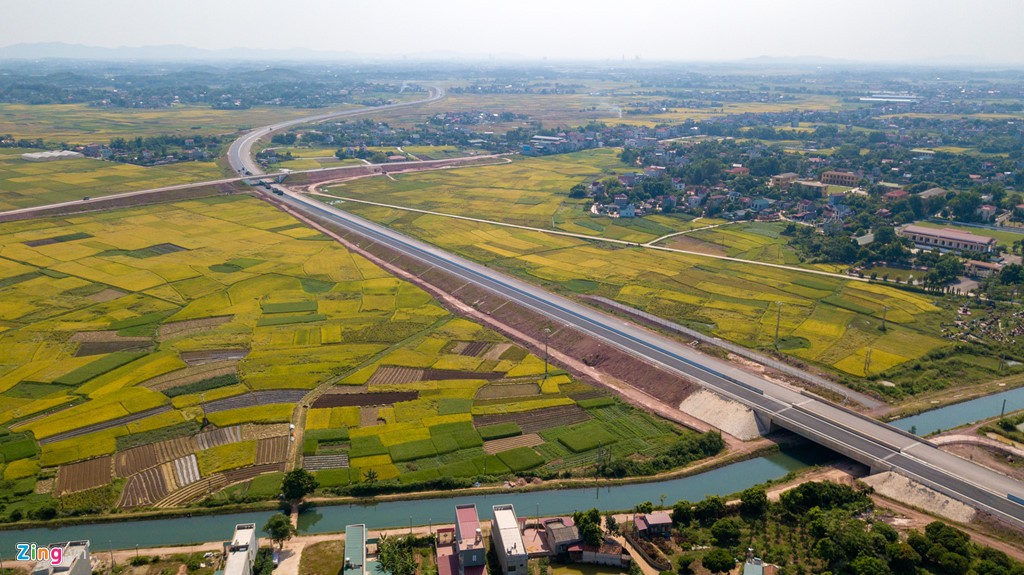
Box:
[0, 0, 1024, 63]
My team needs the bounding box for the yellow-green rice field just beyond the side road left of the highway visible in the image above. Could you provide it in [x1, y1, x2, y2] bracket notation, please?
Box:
[0, 154, 225, 211]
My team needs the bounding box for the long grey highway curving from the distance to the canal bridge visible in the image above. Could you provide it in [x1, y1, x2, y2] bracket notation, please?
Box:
[228, 89, 1024, 527]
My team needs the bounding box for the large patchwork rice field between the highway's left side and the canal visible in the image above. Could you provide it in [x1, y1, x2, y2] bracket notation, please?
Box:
[0, 192, 682, 507]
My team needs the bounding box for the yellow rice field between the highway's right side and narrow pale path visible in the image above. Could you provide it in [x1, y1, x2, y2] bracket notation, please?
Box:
[331, 203, 945, 377]
